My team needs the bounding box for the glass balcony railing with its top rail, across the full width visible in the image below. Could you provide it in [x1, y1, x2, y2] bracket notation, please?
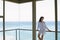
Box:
[0, 29, 60, 40]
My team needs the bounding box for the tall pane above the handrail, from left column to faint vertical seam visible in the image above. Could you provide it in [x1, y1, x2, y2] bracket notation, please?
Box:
[5, 1, 20, 29]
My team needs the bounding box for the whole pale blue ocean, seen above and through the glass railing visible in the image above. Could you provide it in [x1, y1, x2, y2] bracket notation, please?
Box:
[0, 21, 60, 40]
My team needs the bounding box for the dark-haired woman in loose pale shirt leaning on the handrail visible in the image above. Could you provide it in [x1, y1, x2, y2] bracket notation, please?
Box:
[38, 17, 50, 40]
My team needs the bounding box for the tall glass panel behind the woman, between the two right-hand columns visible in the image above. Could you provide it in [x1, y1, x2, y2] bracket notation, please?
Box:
[36, 0, 55, 40]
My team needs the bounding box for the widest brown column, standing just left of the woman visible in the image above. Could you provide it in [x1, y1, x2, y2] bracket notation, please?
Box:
[32, 0, 36, 40]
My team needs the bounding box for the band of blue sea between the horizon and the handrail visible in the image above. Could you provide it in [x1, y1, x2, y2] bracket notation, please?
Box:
[0, 21, 60, 30]
